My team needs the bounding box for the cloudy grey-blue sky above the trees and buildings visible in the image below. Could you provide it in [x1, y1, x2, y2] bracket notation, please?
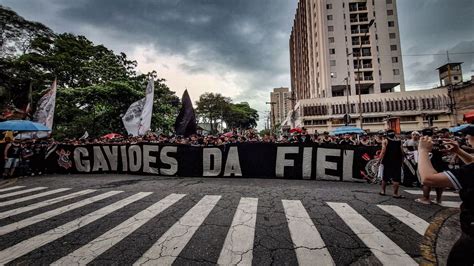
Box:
[0, 0, 474, 125]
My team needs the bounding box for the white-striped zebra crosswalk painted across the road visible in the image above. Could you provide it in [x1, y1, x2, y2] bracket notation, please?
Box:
[0, 186, 462, 265]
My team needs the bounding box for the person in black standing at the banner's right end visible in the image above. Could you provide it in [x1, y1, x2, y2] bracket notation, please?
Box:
[379, 130, 403, 199]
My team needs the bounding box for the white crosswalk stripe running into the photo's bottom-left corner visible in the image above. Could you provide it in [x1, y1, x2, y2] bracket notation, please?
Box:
[0, 192, 152, 265]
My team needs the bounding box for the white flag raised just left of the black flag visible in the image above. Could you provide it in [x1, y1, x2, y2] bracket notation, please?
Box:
[122, 79, 154, 136]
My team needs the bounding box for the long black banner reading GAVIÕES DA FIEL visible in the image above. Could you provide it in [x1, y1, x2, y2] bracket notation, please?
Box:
[46, 143, 380, 181]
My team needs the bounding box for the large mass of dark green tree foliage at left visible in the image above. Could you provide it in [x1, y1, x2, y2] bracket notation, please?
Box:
[0, 6, 179, 138]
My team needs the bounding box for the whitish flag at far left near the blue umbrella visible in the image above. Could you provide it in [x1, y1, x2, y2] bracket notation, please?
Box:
[33, 80, 56, 138]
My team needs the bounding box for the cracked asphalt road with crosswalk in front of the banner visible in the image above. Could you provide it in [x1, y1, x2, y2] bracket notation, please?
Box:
[0, 175, 457, 265]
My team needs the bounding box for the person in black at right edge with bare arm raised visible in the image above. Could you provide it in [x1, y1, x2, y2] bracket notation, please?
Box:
[418, 126, 474, 265]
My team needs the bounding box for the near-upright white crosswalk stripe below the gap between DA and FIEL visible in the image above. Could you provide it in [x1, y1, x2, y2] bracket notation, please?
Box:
[217, 198, 258, 265]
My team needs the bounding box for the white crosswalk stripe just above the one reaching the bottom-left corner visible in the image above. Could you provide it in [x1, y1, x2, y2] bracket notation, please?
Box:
[0, 191, 123, 235]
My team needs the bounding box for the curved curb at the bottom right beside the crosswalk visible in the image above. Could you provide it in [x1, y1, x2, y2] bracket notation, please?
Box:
[420, 208, 459, 266]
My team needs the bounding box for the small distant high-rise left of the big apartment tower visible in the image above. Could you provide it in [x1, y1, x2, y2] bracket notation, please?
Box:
[270, 88, 291, 128]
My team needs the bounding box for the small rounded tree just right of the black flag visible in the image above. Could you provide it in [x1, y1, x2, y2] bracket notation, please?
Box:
[196, 92, 232, 134]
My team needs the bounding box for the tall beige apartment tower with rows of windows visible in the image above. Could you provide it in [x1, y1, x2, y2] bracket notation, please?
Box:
[290, 0, 405, 100]
